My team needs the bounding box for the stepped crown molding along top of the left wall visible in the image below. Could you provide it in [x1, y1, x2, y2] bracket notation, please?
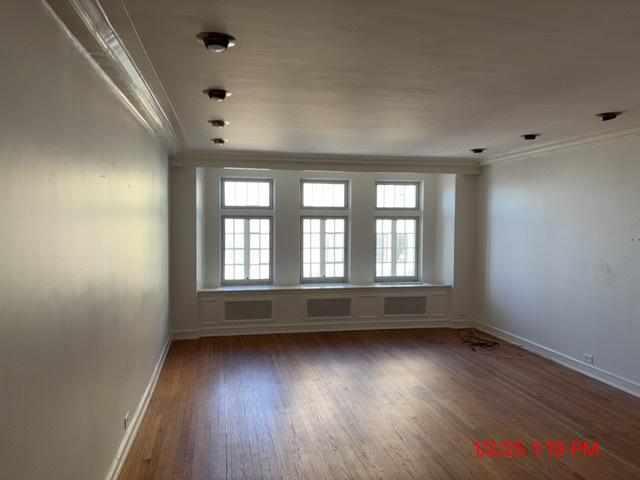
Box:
[41, 0, 186, 153]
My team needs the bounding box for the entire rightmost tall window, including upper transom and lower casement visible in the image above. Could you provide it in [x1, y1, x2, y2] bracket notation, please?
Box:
[375, 182, 420, 281]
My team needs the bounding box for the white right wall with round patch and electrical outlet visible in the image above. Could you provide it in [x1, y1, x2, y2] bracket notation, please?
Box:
[478, 137, 640, 392]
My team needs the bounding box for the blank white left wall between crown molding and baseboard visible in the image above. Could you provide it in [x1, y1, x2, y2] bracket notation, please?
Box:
[0, 0, 168, 480]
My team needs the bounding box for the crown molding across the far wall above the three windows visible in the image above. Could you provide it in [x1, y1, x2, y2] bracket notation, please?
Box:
[169, 150, 480, 175]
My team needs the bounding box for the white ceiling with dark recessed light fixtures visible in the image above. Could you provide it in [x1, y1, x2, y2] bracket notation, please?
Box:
[111, 0, 640, 157]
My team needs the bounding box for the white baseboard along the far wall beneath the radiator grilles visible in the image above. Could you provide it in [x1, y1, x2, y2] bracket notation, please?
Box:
[173, 318, 462, 340]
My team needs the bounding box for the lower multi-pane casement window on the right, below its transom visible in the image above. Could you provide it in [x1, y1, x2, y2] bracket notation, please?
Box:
[376, 217, 418, 280]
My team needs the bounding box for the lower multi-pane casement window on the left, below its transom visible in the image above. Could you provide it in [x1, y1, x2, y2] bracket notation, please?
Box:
[222, 217, 272, 284]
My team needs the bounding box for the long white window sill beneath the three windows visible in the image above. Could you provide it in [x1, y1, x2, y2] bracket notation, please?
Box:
[198, 282, 451, 295]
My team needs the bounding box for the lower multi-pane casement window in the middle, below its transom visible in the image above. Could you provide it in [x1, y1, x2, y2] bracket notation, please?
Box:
[302, 217, 347, 282]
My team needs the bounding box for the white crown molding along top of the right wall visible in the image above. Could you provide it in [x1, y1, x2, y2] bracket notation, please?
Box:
[480, 121, 640, 166]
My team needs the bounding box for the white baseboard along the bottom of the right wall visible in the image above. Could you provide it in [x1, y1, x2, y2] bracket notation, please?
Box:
[475, 321, 640, 397]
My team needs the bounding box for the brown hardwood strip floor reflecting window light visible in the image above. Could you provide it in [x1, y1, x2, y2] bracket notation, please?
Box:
[120, 329, 640, 480]
